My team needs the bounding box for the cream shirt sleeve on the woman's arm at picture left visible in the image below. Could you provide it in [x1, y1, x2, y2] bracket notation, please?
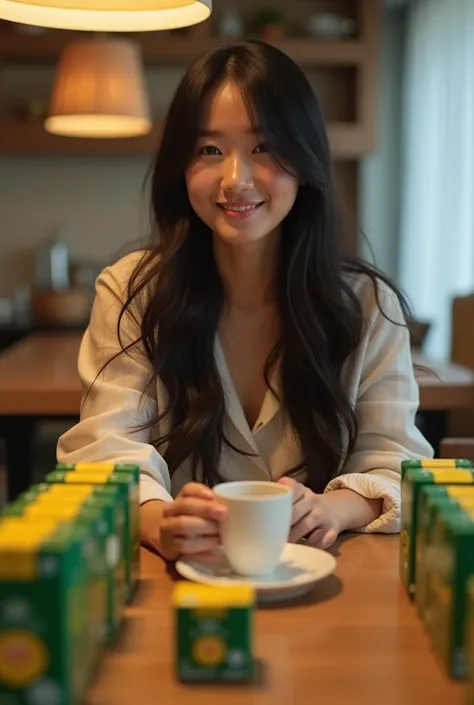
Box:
[57, 256, 172, 503]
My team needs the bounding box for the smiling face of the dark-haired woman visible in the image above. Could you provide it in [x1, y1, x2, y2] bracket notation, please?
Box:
[186, 84, 298, 244]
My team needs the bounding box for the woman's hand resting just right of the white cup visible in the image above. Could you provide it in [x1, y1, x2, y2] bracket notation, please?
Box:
[279, 477, 342, 549]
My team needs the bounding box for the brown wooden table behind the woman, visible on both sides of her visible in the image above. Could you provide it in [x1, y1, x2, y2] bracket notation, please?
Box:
[0, 333, 474, 416]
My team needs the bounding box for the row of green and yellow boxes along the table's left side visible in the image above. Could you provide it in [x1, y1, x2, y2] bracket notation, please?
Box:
[0, 463, 140, 705]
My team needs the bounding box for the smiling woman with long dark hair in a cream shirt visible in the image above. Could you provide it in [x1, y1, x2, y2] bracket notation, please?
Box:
[58, 42, 431, 559]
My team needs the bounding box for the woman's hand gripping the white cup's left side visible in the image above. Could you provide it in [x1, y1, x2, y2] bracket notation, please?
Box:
[141, 482, 226, 561]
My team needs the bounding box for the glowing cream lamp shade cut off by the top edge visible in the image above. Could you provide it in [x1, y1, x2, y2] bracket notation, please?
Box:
[0, 0, 212, 32]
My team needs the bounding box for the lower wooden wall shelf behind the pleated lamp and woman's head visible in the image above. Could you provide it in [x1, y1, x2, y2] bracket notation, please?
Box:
[0, 120, 372, 159]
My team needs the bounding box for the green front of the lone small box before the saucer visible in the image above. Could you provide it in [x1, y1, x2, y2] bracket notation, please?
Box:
[176, 607, 254, 683]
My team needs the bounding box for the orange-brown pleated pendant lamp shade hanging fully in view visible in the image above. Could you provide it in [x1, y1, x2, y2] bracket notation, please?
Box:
[45, 38, 151, 138]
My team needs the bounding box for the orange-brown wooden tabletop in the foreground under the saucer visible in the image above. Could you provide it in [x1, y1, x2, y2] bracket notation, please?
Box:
[86, 535, 466, 705]
